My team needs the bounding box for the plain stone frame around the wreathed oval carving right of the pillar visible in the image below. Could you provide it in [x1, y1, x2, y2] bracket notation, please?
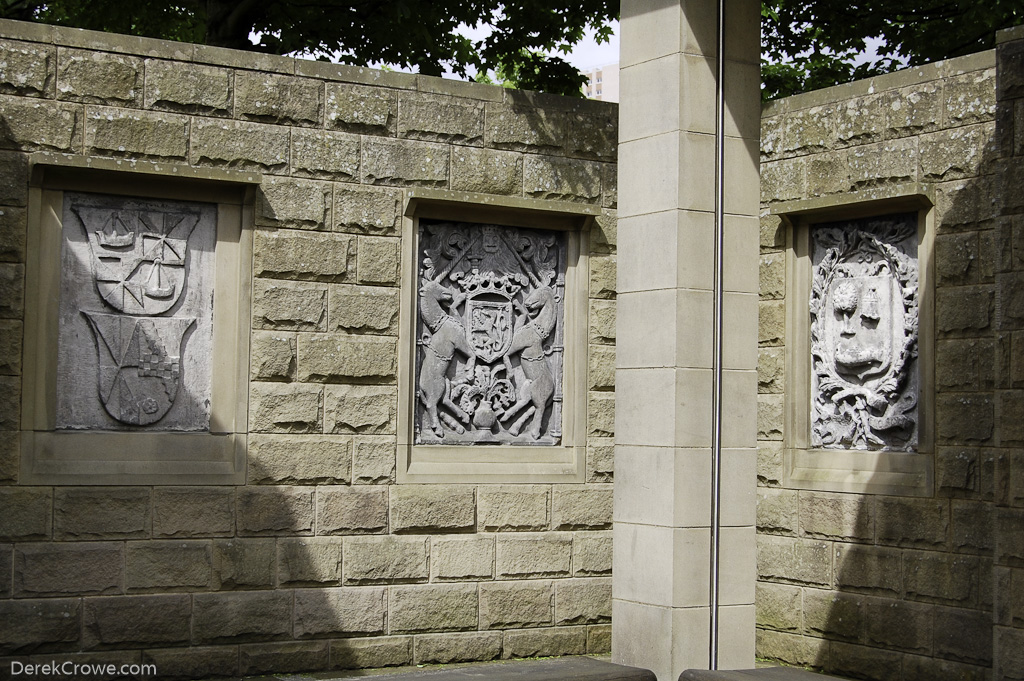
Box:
[772, 183, 935, 497]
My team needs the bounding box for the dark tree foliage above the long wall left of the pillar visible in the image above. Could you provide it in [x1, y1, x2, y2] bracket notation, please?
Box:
[0, 0, 606, 96]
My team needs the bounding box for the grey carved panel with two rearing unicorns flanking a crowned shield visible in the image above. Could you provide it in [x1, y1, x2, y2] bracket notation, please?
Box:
[416, 220, 566, 444]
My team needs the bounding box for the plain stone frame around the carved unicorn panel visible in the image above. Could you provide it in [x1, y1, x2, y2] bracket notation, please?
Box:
[395, 189, 600, 483]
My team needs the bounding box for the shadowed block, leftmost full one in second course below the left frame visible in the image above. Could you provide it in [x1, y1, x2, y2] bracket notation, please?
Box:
[13, 542, 124, 598]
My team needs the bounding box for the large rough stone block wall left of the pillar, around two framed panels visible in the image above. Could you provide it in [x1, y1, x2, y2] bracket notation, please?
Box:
[0, 22, 616, 678]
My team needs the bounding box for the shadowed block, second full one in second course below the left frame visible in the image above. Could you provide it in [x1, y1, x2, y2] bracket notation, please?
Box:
[125, 541, 213, 592]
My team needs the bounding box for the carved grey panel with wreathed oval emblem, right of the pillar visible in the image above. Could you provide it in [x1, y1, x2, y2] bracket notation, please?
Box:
[810, 213, 919, 452]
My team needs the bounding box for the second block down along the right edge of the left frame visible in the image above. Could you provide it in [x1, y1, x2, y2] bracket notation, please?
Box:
[253, 231, 352, 282]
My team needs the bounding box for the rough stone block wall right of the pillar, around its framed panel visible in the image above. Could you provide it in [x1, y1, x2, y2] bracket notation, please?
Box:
[757, 45, 1003, 681]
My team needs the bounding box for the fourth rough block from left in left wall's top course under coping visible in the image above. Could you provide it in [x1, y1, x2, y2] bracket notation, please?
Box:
[234, 71, 324, 126]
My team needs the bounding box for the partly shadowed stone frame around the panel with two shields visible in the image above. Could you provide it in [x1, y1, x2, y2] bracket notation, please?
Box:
[19, 154, 253, 485]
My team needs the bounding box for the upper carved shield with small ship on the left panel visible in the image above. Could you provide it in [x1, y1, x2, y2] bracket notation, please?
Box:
[73, 206, 199, 314]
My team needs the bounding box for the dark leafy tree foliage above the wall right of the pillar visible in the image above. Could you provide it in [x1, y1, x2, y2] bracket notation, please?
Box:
[761, 0, 1024, 99]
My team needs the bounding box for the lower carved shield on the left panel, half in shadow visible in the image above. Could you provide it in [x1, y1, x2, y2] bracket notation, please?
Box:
[82, 311, 196, 426]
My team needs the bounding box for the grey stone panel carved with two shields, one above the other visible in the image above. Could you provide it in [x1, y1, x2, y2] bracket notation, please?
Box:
[56, 191, 216, 431]
